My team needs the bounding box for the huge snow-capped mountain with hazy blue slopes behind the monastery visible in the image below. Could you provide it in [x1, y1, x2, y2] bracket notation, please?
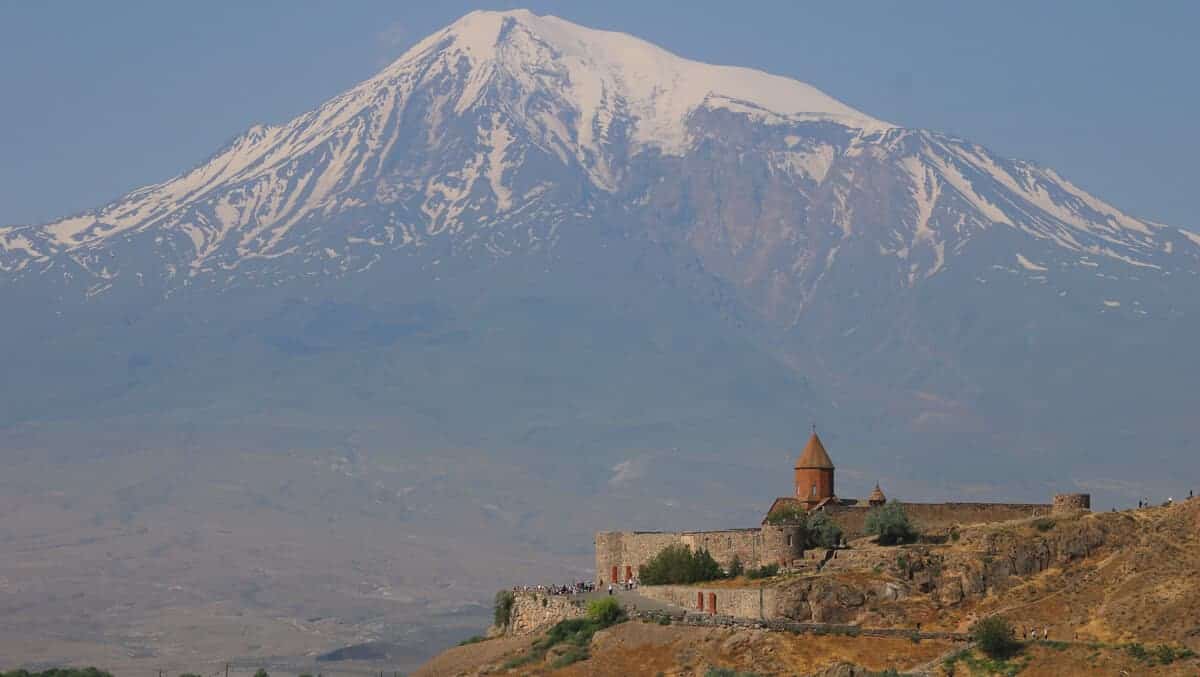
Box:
[0, 11, 1200, 497]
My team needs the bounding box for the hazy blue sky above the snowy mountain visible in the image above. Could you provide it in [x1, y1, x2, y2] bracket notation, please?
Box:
[0, 0, 1200, 228]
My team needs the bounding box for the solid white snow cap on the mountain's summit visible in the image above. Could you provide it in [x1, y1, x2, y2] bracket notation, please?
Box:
[389, 10, 894, 152]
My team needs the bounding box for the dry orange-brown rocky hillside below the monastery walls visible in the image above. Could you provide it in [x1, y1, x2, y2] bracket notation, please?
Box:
[418, 499, 1200, 676]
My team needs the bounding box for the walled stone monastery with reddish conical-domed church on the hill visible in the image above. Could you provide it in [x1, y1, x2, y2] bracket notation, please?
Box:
[595, 431, 1091, 583]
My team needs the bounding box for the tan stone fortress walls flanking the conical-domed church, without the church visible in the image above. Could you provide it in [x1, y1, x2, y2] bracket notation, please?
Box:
[595, 493, 1091, 585]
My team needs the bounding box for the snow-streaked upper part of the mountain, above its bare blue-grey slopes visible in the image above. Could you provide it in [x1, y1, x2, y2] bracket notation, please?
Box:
[0, 10, 1200, 301]
